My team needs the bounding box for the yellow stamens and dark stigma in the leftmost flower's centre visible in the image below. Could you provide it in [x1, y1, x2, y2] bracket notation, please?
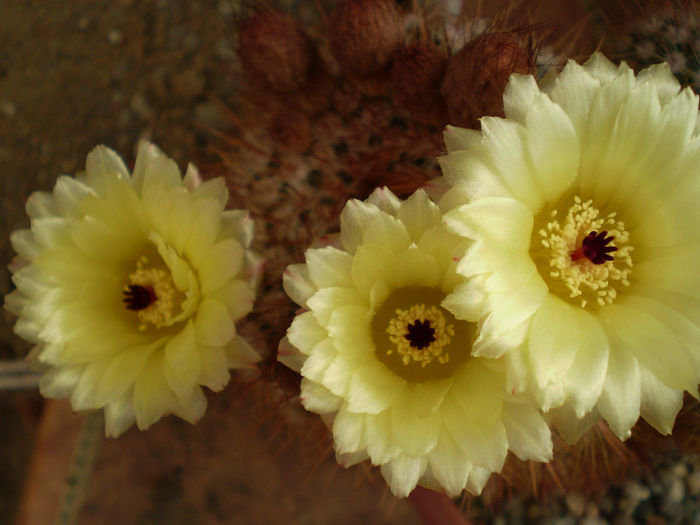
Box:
[123, 255, 176, 331]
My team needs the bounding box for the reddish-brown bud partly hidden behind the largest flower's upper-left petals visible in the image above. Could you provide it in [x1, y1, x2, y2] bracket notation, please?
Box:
[442, 33, 535, 128]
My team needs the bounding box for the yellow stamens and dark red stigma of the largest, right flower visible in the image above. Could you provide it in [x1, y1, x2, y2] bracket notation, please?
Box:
[538, 196, 633, 308]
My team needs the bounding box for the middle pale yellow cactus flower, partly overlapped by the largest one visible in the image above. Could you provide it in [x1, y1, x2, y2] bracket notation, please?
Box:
[279, 189, 552, 497]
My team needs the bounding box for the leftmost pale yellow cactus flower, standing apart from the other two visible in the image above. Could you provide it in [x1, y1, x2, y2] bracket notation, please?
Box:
[5, 143, 259, 436]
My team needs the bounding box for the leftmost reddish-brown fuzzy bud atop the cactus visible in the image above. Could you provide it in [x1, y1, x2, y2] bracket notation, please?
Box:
[238, 10, 314, 93]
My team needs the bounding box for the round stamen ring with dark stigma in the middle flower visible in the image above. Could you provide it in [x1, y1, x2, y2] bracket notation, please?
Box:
[386, 304, 455, 368]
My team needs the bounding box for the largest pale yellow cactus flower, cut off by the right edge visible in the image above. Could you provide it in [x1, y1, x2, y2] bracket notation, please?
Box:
[441, 54, 700, 439]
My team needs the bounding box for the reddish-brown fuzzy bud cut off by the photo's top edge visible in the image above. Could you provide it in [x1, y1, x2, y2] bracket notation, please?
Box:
[329, 0, 403, 77]
